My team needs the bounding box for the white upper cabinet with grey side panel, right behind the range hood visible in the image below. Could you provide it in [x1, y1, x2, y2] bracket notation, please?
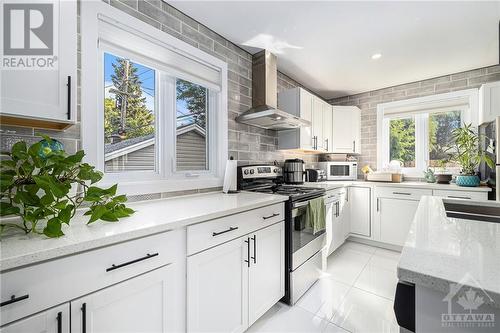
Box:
[278, 88, 333, 152]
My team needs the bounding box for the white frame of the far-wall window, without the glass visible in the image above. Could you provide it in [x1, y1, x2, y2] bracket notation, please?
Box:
[377, 89, 479, 178]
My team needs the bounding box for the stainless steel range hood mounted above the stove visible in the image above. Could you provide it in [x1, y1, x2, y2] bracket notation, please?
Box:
[236, 50, 311, 130]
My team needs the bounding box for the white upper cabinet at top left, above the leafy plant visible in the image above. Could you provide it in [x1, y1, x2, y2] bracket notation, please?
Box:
[0, 0, 77, 129]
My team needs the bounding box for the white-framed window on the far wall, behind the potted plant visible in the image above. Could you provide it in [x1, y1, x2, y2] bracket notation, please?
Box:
[377, 89, 477, 177]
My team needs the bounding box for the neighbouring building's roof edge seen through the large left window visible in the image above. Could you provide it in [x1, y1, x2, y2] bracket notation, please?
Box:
[104, 124, 206, 161]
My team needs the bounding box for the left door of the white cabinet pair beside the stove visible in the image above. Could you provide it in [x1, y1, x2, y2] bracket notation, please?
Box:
[187, 236, 250, 333]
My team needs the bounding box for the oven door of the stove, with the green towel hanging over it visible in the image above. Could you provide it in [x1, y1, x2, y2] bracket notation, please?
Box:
[291, 201, 326, 271]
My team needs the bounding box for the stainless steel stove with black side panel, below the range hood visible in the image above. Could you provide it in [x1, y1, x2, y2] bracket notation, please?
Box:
[238, 165, 325, 304]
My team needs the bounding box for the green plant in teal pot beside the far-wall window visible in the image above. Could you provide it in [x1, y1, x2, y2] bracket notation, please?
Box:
[451, 124, 495, 187]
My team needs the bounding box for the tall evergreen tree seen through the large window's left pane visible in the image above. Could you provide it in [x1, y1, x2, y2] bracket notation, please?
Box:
[104, 58, 155, 143]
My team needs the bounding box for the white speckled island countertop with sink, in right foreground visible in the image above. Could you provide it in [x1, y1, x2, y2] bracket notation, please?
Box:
[398, 196, 500, 307]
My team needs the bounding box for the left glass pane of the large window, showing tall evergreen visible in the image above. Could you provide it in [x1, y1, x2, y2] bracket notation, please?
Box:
[104, 52, 157, 173]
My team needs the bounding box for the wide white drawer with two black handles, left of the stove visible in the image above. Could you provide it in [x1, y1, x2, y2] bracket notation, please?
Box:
[187, 203, 285, 255]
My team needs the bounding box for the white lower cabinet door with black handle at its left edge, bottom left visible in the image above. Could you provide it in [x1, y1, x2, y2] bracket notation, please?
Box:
[71, 264, 179, 333]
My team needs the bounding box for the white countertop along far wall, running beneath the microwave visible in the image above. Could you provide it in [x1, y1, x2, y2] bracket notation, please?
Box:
[304, 180, 491, 192]
